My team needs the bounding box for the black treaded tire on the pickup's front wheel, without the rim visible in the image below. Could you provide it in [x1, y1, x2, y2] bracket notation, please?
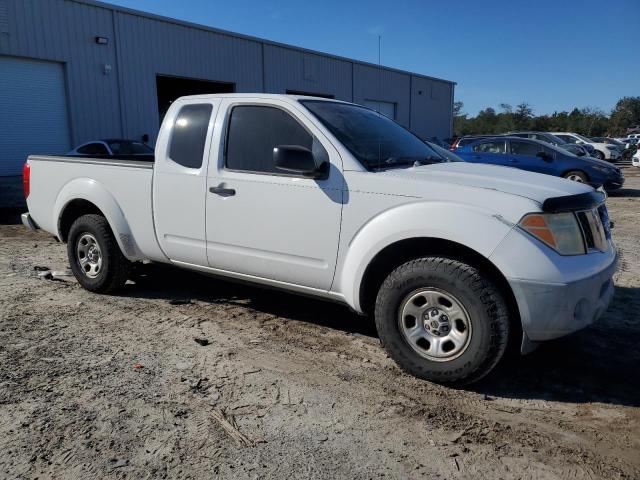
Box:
[375, 257, 509, 385]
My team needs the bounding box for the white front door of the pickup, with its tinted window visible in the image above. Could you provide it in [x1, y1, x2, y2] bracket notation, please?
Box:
[206, 99, 344, 290]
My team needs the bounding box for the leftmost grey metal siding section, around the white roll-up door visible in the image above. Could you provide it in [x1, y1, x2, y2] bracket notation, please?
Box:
[0, 0, 120, 143]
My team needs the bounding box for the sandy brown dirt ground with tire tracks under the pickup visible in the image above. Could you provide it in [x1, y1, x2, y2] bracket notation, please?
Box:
[0, 177, 640, 479]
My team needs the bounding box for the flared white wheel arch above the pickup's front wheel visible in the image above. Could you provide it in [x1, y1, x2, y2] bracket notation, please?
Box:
[334, 202, 513, 313]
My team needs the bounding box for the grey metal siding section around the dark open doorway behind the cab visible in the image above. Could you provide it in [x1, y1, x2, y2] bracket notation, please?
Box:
[116, 12, 262, 140]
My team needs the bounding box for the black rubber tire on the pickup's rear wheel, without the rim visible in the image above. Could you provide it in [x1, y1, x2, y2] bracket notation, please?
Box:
[67, 214, 131, 293]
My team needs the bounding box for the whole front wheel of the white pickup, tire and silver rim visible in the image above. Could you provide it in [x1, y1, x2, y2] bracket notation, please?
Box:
[375, 257, 509, 385]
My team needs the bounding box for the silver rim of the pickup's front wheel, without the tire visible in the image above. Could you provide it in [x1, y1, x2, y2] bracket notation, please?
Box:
[398, 288, 472, 362]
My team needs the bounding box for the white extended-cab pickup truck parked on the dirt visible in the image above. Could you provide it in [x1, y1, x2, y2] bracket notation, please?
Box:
[23, 94, 617, 384]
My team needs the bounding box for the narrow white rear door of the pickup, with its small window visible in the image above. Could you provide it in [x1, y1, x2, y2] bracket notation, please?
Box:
[153, 98, 220, 266]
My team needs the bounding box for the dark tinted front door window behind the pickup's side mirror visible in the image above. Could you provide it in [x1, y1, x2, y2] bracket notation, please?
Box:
[226, 105, 316, 174]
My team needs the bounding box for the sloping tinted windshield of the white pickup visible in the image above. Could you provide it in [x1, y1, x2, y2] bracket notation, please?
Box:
[300, 100, 446, 170]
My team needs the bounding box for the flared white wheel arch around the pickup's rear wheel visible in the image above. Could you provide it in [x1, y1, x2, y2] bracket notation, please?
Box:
[51, 178, 144, 261]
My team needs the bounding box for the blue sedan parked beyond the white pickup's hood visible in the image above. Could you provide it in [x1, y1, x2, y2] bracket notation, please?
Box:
[455, 137, 624, 190]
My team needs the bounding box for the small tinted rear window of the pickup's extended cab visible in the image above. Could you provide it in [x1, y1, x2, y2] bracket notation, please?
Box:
[169, 104, 212, 168]
